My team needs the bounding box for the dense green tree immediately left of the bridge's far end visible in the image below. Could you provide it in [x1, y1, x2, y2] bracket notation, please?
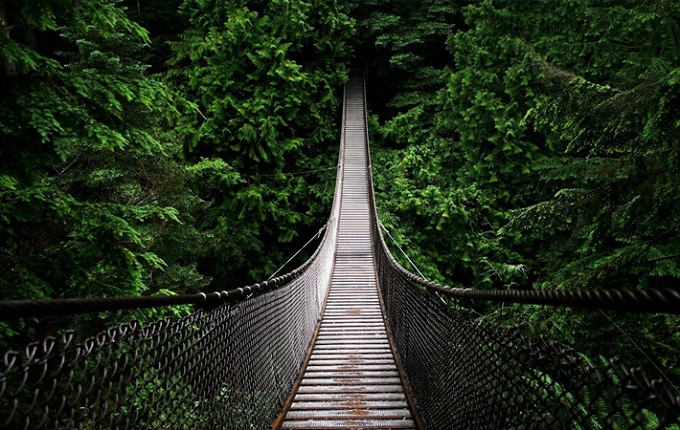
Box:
[170, 1, 353, 285]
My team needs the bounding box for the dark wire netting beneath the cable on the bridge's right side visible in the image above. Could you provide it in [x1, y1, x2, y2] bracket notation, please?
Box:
[377, 246, 680, 429]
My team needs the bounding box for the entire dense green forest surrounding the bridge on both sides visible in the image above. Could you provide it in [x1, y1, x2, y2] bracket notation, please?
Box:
[0, 0, 680, 380]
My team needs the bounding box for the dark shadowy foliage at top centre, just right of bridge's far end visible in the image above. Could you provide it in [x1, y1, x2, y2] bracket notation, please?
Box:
[352, 0, 460, 116]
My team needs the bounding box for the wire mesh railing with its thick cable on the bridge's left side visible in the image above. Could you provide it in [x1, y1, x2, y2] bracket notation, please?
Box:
[0, 85, 344, 430]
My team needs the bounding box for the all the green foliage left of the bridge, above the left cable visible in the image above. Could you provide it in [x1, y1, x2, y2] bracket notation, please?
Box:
[0, 0, 353, 319]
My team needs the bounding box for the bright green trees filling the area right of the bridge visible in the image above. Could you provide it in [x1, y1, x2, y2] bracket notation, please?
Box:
[366, 0, 680, 381]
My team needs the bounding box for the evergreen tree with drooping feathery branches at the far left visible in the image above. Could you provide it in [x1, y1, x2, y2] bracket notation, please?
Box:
[0, 0, 206, 306]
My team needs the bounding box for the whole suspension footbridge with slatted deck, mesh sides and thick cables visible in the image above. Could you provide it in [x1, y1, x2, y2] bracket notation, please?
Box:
[0, 76, 680, 429]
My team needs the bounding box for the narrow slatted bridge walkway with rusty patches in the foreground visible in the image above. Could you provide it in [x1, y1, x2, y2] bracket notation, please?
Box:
[281, 79, 416, 429]
